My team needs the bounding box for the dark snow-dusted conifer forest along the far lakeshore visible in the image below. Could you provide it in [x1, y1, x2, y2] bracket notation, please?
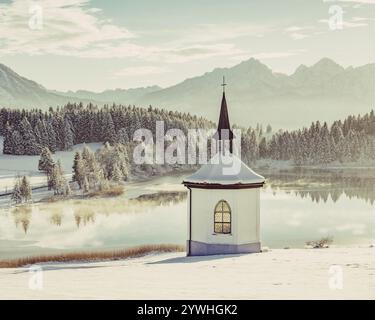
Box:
[0, 103, 375, 169]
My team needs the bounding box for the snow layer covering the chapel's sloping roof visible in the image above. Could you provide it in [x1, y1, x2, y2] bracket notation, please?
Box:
[184, 153, 265, 185]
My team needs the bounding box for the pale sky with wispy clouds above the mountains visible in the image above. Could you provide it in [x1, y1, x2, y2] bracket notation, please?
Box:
[0, 0, 375, 91]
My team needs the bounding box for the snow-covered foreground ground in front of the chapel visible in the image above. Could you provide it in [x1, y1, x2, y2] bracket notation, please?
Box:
[0, 248, 375, 299]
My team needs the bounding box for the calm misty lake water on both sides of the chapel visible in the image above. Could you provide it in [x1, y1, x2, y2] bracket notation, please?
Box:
[0, 169, 375, 259]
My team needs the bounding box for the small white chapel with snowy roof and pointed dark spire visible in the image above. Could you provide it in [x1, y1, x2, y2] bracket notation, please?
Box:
[183, 83, 265, 256]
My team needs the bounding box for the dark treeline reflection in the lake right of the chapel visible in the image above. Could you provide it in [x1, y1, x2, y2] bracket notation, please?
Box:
[267, 169, 375, 205]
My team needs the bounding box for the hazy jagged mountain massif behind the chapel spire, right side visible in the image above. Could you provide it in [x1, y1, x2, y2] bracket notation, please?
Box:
[135, 58, 375, 128]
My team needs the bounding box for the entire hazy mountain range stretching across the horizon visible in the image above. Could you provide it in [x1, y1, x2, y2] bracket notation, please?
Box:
[0, 58, 375, 129]
